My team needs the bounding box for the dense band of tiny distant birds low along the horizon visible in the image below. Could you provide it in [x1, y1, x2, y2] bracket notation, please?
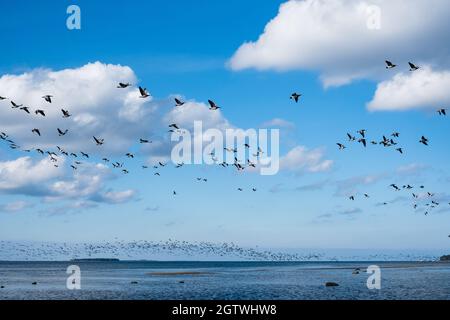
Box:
[0, 239, 323, 261]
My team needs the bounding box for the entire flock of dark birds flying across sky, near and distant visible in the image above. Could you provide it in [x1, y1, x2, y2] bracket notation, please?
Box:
[0, 60, 450, 260]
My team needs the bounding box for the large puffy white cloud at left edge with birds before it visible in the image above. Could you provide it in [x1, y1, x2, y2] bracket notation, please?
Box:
[0, 62, 159, 153]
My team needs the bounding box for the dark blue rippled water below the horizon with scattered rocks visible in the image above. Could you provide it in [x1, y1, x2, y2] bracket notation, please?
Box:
[0, 261, 450, 300]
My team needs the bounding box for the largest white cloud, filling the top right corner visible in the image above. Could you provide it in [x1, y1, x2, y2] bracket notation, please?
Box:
[229, 0, 450, 86]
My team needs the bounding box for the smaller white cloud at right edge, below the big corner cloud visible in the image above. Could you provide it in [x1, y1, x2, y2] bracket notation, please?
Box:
[367, 67, 450, 111]
